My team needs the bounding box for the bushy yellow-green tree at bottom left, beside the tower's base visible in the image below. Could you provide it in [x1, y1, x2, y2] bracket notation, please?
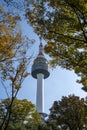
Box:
[0, 98, 51, 130]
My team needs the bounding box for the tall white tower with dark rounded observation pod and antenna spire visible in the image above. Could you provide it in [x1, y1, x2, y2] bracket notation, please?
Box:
[31, 42, 50, 114]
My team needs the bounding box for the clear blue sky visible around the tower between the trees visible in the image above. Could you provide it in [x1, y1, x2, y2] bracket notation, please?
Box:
[0, 2, 87, 113]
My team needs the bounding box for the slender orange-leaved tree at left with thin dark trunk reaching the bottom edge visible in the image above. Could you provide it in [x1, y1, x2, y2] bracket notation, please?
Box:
[0, 8, 32, 130]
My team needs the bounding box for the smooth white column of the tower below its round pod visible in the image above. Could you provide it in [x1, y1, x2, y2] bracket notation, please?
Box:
[36, 73, 44, 113]
